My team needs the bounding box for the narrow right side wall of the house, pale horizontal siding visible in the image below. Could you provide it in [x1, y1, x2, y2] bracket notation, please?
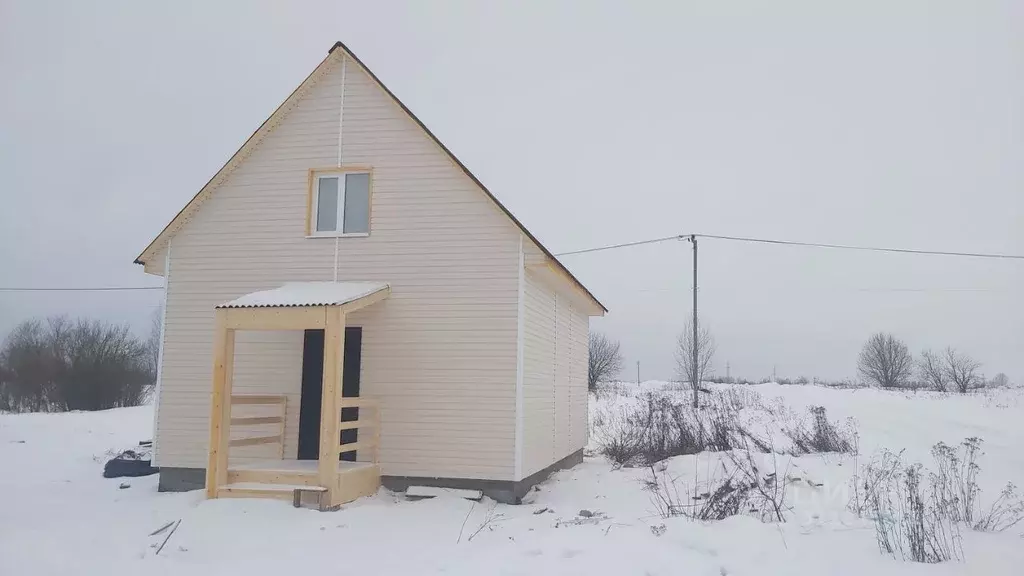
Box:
[522, 264, 590, 477]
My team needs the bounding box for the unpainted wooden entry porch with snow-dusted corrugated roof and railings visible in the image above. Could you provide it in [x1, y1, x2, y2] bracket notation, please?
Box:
[206, 282, 390, 506]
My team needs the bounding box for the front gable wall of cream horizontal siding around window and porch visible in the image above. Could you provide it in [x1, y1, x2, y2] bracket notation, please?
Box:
[158, 50, 519, 480]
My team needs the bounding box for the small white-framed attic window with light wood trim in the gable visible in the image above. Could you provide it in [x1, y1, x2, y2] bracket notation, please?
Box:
[309, 170, 370, 236]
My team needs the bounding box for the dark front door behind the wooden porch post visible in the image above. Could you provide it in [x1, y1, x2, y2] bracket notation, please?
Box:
[298, 326, 362, 460]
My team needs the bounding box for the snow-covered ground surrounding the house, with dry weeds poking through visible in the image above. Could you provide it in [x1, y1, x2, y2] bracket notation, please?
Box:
[0, 383, 1024, 576]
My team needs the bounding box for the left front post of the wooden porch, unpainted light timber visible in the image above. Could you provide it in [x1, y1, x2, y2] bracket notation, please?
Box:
[206, 308, 234, 498]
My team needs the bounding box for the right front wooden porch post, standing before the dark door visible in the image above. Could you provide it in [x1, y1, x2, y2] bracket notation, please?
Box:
[317, 306, 345, 498]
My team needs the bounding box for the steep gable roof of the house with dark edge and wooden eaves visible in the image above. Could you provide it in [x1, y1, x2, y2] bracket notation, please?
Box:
[135, 41, 608, 312]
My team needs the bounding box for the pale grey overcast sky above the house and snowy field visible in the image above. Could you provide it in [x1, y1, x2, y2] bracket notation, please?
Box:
[0, 0, 1024, 381]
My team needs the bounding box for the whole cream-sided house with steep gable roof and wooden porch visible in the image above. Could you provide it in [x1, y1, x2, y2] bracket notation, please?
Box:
[135, 42, 607, 505]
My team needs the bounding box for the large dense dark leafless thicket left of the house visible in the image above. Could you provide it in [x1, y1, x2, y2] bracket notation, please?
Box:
[0, 317, 155, 411]
